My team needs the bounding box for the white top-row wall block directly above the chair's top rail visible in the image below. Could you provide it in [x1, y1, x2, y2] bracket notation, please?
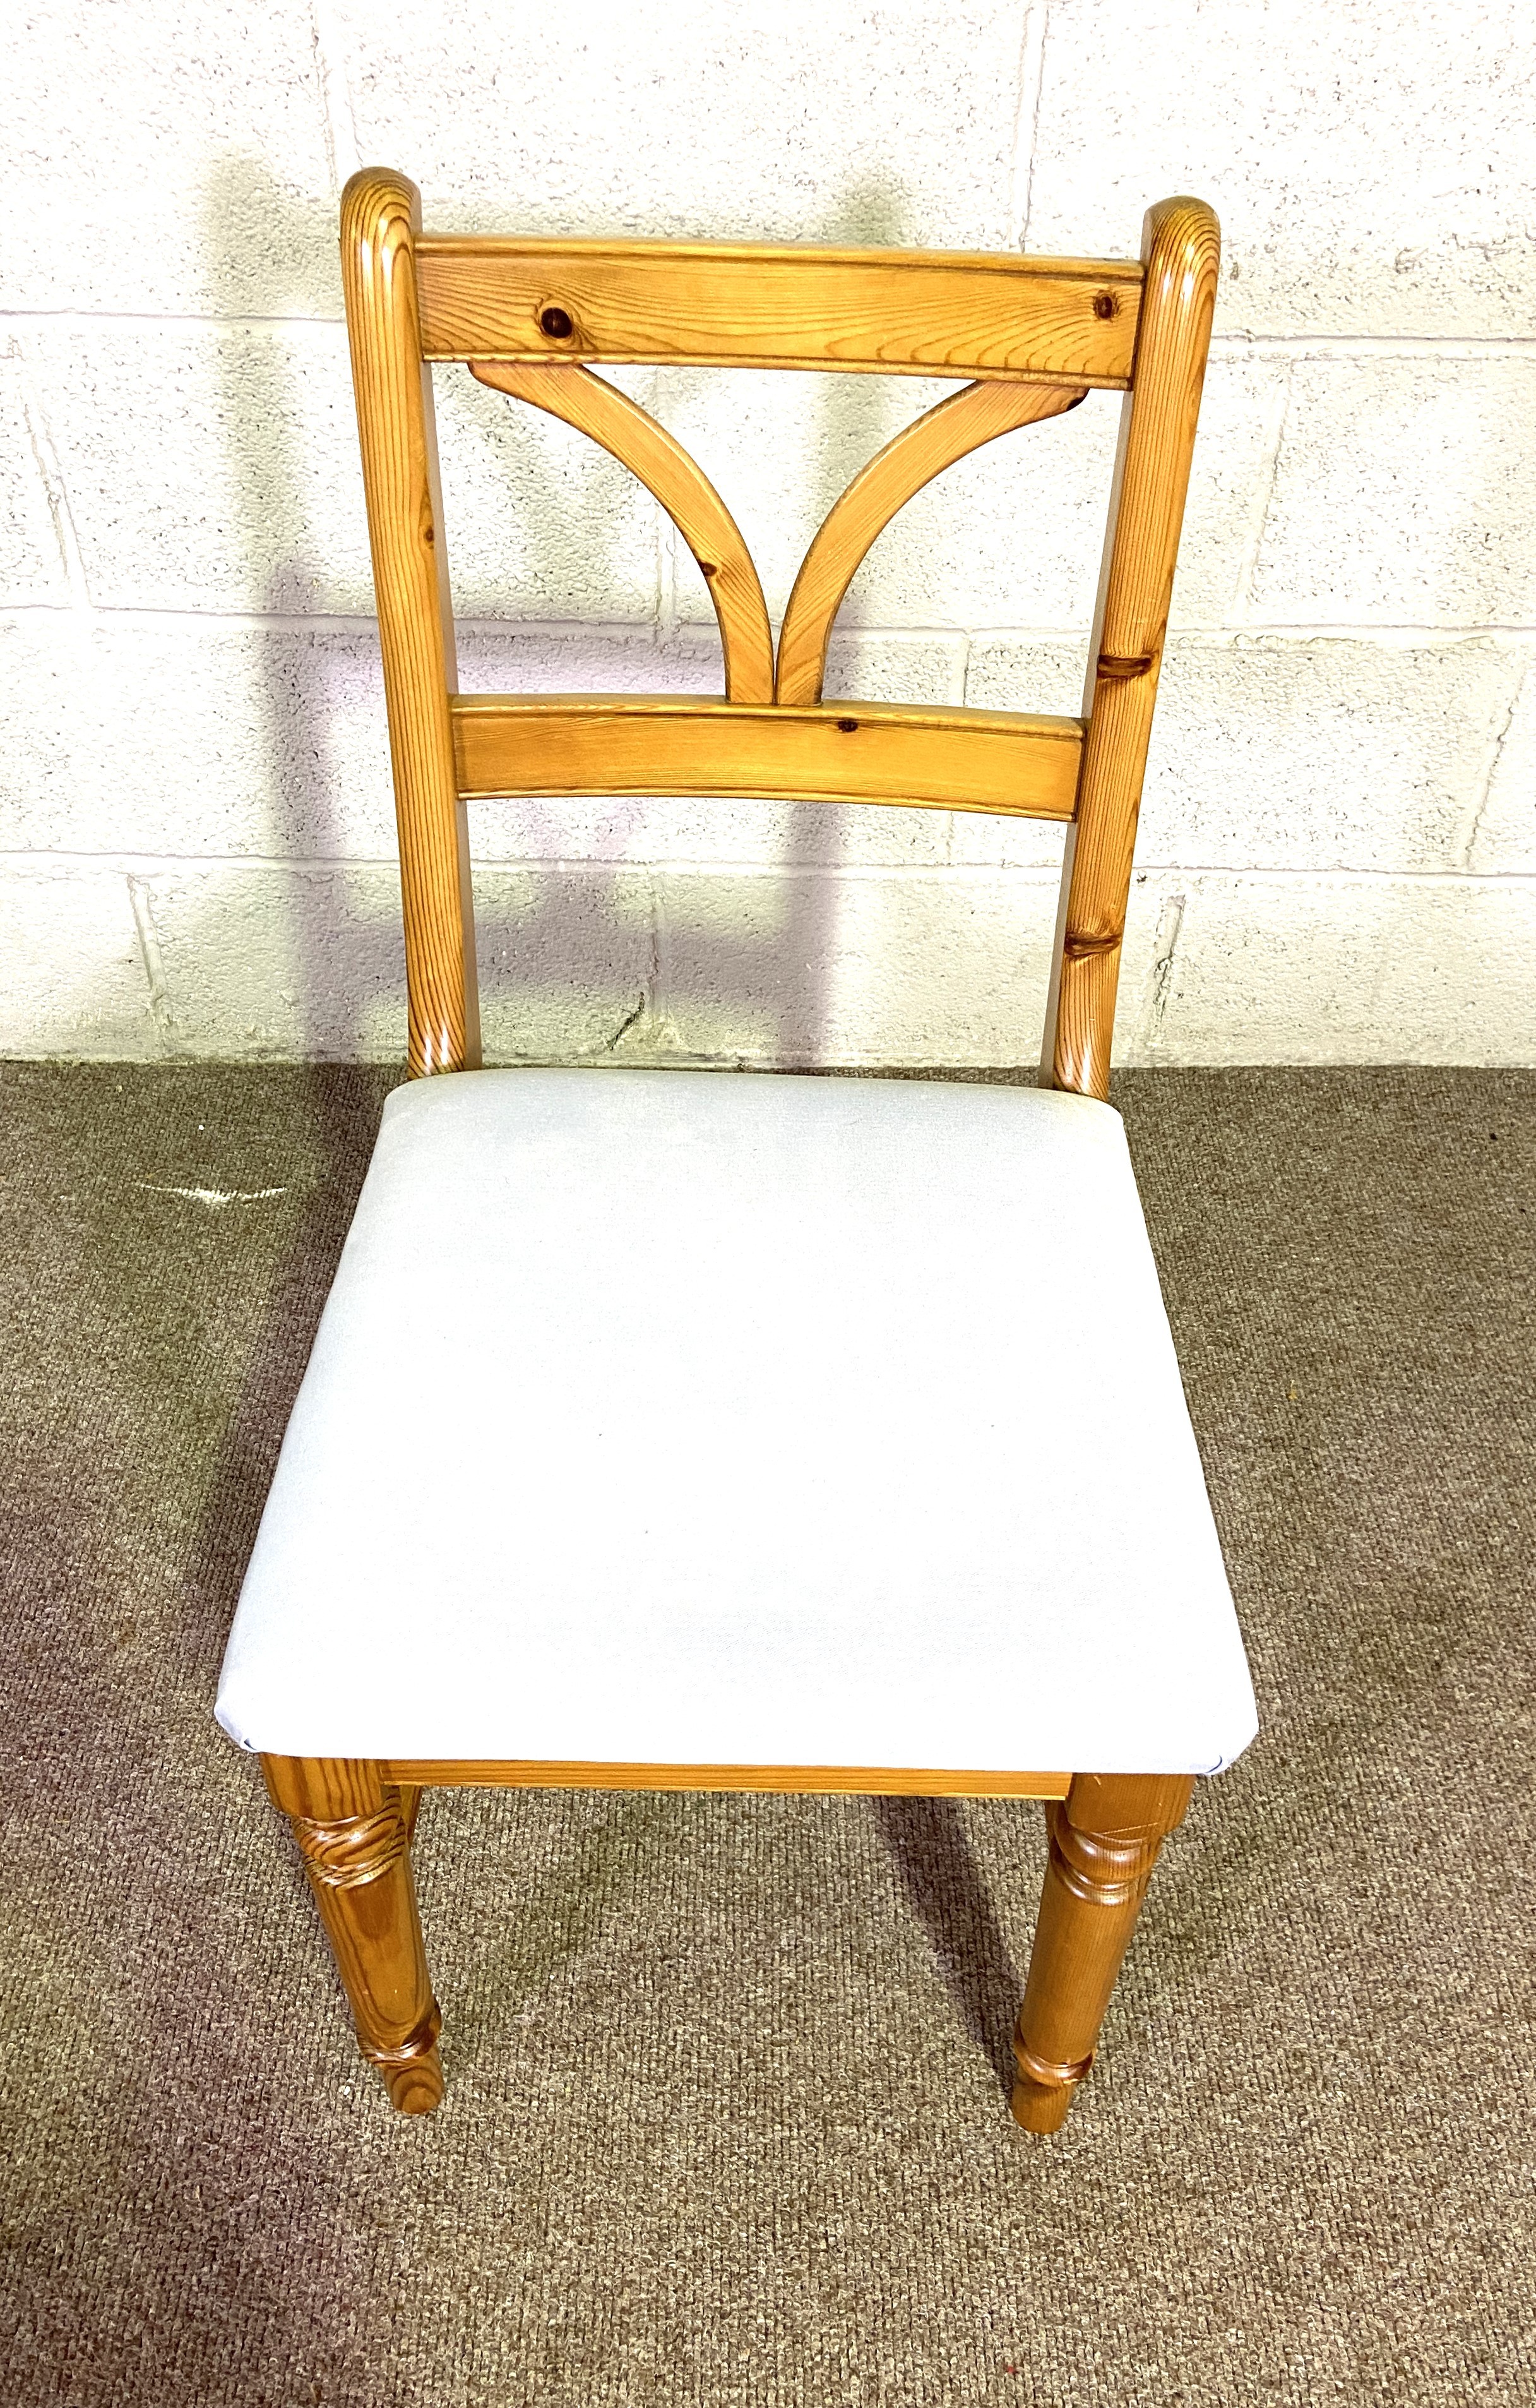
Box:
[330, 0, 1021, 248]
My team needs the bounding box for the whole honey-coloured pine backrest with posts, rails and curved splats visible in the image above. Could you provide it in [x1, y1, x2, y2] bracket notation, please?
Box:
[342, 169, 1220, 1096]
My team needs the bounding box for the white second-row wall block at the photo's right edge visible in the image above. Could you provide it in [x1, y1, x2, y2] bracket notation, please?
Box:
[1252, 352, 1536, 626]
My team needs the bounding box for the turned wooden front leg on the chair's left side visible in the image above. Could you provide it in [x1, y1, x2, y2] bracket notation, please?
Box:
[263, 1756, 443, 2114]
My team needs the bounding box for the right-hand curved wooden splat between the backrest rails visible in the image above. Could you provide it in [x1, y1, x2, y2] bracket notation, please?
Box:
[778, 383, 1088, 703]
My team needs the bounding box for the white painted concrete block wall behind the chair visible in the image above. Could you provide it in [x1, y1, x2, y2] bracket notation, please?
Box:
[0, 0, 1536, 1064]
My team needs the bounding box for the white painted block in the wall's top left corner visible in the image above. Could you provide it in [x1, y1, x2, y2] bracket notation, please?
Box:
[0, 0, 340, 316]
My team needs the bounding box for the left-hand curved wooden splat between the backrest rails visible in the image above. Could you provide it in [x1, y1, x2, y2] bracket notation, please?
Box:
[470, 359, 773, 703]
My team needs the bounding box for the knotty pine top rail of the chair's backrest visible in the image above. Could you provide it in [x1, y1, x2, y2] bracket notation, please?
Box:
[417, 234, 1141, 388]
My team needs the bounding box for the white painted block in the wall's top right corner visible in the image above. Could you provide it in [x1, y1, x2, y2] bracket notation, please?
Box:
[1028, 0, 1536, 335]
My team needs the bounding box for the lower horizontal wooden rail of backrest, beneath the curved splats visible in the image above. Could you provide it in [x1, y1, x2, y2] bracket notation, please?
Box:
[453, 693, 1083, 818]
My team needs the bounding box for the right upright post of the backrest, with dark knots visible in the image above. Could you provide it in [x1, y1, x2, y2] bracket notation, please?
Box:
[1042, 200, 1220, 1098]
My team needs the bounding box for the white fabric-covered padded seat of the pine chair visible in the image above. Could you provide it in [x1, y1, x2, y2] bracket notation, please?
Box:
[219, 1069, 1254, 1772]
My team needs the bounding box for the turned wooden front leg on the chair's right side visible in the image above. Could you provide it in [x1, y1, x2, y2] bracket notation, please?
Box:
[1013, 1772, 1194, 2131]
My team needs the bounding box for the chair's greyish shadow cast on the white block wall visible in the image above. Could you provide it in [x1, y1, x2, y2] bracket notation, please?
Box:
[193, 159, 1069, 1067]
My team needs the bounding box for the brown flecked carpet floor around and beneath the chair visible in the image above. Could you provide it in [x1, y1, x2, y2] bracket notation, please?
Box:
[0, 1067, 1536, 2408]
